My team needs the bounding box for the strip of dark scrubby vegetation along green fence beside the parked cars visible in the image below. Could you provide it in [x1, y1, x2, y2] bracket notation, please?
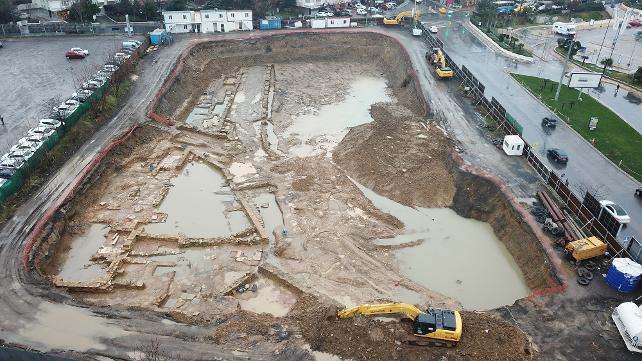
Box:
[0, 79, 131, 225]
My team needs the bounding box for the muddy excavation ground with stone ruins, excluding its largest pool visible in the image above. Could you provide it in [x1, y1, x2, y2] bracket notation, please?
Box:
[28, 34, 554, 360]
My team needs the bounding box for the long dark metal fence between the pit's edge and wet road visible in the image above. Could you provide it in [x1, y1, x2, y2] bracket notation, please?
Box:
[418, 23, 642, 262]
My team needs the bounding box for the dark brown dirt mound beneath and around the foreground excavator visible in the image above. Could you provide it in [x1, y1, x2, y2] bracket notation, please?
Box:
[290, 298, 538, 361]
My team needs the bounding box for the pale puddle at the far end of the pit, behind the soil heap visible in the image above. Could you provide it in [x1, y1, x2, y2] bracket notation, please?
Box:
[285, 77, 391, 157]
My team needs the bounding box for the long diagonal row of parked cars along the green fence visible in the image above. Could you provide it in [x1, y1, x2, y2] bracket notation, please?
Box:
[0, 41, 142, 186]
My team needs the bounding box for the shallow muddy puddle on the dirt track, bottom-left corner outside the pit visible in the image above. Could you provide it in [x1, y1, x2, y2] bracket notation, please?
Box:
[17, 302, 129, 351]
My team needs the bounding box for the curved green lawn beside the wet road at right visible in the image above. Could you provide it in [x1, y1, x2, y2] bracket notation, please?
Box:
[511, 74, 642, 181]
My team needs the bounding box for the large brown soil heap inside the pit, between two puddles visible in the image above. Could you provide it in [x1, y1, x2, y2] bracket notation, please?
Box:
[333, 105, 456, 208]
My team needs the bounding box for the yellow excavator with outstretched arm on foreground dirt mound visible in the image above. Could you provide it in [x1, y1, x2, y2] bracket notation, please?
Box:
[337, 303, 462, 347]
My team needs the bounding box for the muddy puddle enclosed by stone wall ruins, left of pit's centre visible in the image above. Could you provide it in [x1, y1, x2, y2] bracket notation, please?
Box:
[145, 162, 249, 238]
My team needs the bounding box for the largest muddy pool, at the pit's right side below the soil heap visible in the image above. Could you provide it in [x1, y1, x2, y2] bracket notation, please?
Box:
[355, 183, 530, 310]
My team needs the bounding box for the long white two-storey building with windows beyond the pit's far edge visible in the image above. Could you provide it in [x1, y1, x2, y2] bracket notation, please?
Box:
[163, 10, 253, 33]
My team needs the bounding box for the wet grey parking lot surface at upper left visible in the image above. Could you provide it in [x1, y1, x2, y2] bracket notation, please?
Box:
[0, 36, 141, 153]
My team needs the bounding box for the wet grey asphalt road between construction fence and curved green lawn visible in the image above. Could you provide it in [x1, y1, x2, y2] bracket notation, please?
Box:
[422, 14, 642, 245]
